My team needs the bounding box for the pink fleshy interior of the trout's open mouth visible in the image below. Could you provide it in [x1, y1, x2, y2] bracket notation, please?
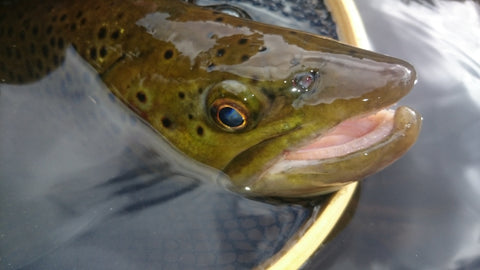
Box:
[284, 110, 394, 160]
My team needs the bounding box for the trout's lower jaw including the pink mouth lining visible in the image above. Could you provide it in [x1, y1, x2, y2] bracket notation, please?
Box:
[248, 107, 422, 197]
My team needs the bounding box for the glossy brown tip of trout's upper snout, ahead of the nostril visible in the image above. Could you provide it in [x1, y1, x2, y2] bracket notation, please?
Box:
[293, 54, 416, 110]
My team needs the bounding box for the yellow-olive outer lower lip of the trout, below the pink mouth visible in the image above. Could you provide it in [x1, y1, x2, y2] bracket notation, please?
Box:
[248, 106, 422, 197]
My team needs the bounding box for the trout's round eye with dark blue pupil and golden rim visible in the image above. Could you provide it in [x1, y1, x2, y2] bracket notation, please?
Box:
[210, 98, 248, 131]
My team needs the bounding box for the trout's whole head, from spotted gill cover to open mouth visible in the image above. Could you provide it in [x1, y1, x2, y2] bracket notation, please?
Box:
[104, 5, 421, 197]
